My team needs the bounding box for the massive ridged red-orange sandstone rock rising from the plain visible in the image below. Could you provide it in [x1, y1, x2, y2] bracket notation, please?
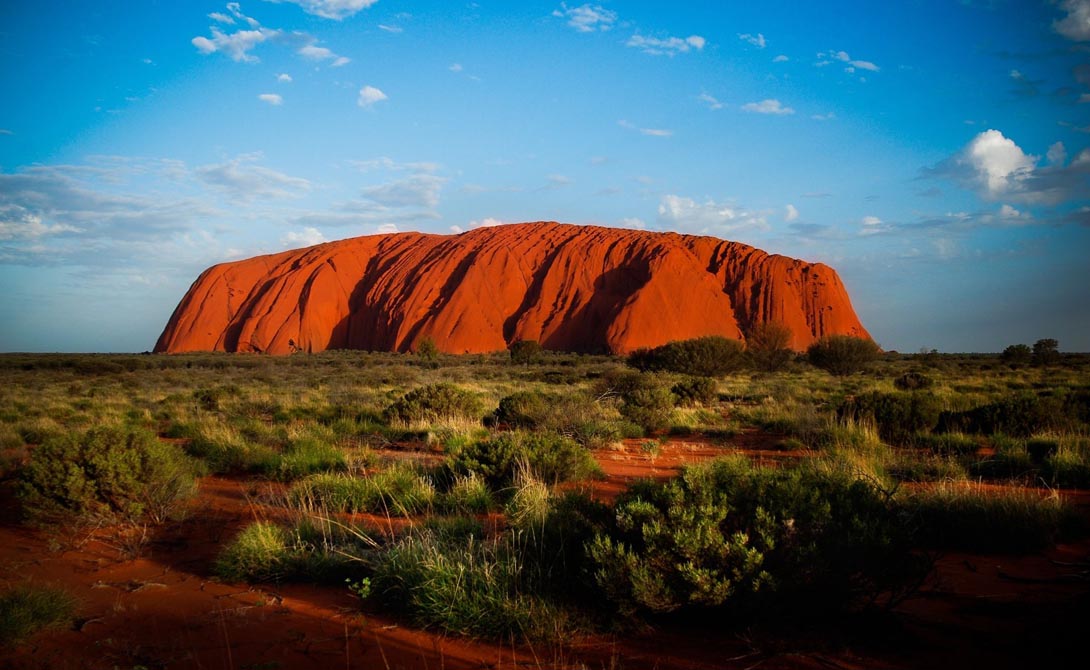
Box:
[155, 223, 870, 354]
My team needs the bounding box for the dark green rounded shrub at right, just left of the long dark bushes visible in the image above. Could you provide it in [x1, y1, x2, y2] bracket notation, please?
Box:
[837, 391, 943, 446]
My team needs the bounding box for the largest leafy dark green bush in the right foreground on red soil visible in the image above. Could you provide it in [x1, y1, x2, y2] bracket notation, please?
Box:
[588, 459, 920, 614]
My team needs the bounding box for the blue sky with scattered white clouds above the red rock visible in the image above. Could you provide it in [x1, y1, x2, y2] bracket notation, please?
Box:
[0, 0, 1090, 352]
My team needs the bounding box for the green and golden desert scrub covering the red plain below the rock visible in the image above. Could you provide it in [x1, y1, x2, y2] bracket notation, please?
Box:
[0, 331, 1090, 653]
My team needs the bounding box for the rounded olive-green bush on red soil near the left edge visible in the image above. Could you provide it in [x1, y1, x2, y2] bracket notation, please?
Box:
[20, 427, 196, 522]
